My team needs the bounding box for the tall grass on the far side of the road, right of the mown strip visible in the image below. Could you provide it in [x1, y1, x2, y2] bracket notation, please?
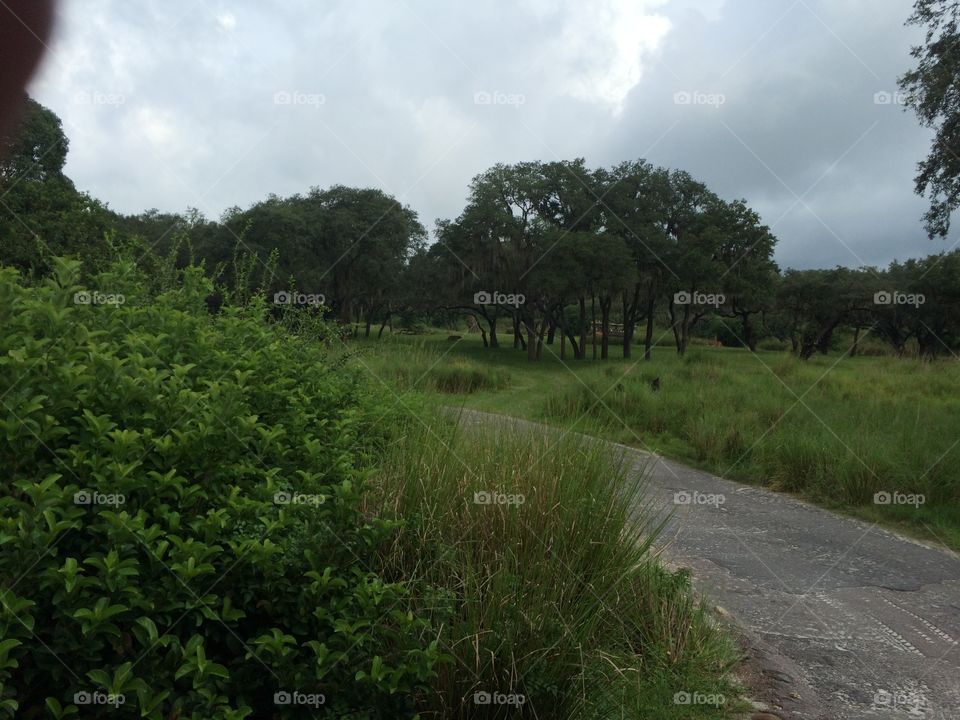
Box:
[542, 349, 960, 547]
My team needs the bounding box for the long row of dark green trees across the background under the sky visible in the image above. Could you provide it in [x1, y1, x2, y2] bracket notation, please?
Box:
[0, 97, 960, 360]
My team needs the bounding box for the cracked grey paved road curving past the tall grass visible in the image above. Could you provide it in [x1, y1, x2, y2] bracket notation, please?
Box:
[452, 411, 960, 720]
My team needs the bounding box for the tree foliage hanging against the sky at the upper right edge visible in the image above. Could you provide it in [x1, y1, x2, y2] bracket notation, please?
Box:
[900, 0, 960, 237]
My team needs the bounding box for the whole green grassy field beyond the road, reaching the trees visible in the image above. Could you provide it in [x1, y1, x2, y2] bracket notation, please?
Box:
[353, 331, 960, 549]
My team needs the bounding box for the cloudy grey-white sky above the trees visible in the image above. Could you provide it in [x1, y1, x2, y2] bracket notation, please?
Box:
[31, 0, 956, 267]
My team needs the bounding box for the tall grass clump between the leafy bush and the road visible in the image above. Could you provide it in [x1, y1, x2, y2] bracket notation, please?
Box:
[369, 418, 736, 719]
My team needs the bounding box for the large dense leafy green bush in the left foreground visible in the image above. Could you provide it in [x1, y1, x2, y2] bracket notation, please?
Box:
[0, 260, 439, 720]
